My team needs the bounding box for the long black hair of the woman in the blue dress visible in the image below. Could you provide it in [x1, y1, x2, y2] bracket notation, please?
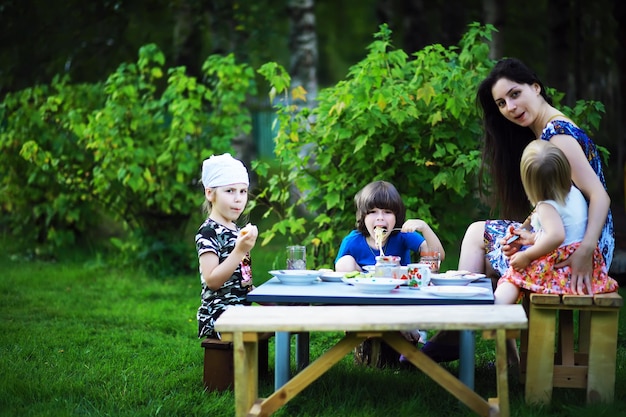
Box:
[476, 58, 552, 221]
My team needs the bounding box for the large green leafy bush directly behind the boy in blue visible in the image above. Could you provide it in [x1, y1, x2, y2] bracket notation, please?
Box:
[255, 24, 493, 266]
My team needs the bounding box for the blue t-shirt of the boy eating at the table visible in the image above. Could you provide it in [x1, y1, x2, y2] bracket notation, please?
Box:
[335, 230, 425, 267]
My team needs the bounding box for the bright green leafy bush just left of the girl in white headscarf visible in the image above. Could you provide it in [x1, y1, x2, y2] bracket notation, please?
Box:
[72, 45, 254, 228]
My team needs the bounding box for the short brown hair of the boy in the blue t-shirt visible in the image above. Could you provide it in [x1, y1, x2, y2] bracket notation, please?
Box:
[354, 181, 406, 236]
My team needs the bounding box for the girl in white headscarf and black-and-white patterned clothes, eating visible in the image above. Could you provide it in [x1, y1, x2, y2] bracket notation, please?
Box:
[196, 154, 259, 339]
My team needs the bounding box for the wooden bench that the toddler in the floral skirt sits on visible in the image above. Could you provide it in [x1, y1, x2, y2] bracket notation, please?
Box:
[520, 293, 623, 404]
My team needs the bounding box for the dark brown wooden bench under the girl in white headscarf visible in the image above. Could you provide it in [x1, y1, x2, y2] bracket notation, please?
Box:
[200, 335, 269, 391]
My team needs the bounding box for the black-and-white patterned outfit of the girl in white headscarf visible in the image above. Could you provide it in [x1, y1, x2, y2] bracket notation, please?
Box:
[196, 219, 252, 338]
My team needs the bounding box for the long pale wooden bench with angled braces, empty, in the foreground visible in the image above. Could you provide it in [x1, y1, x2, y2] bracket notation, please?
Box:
[215, 305, 528, 417]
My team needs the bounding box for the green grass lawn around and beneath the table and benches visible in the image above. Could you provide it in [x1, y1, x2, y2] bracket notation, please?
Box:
[0, 231, 626, 417]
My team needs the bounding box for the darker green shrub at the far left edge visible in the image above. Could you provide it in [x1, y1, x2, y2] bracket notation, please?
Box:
[0, 78, 103, 254]
